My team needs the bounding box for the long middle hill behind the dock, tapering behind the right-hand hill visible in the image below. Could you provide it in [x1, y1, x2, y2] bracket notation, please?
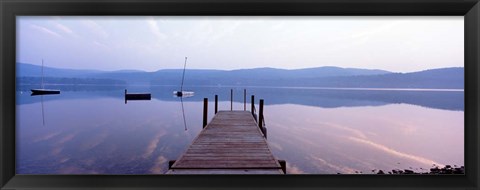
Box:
[151, 67, 391, 86]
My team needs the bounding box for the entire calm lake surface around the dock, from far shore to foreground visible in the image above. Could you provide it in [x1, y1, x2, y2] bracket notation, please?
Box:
[16, 86, 464, 174]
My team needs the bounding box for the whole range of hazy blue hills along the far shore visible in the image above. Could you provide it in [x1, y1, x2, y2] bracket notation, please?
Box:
[17, 63, 464, 89]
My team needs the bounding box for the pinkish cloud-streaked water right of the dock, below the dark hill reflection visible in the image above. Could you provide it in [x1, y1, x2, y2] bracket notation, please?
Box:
[265, 104, 464, 173]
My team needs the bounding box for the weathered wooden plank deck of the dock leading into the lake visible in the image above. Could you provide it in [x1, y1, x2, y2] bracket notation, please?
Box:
[167, 111, 284, 174]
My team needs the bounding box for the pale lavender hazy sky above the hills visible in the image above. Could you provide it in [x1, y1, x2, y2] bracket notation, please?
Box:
[17, 16, 464, 72]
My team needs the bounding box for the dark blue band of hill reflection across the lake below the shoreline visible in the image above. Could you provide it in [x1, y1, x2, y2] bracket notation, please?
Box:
[17, 85, 464, 111]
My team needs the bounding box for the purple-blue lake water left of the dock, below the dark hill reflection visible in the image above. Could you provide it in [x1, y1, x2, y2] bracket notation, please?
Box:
[17, 96, 202, 174]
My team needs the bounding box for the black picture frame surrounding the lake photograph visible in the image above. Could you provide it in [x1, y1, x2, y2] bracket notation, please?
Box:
[0, 0, 480, 189]
